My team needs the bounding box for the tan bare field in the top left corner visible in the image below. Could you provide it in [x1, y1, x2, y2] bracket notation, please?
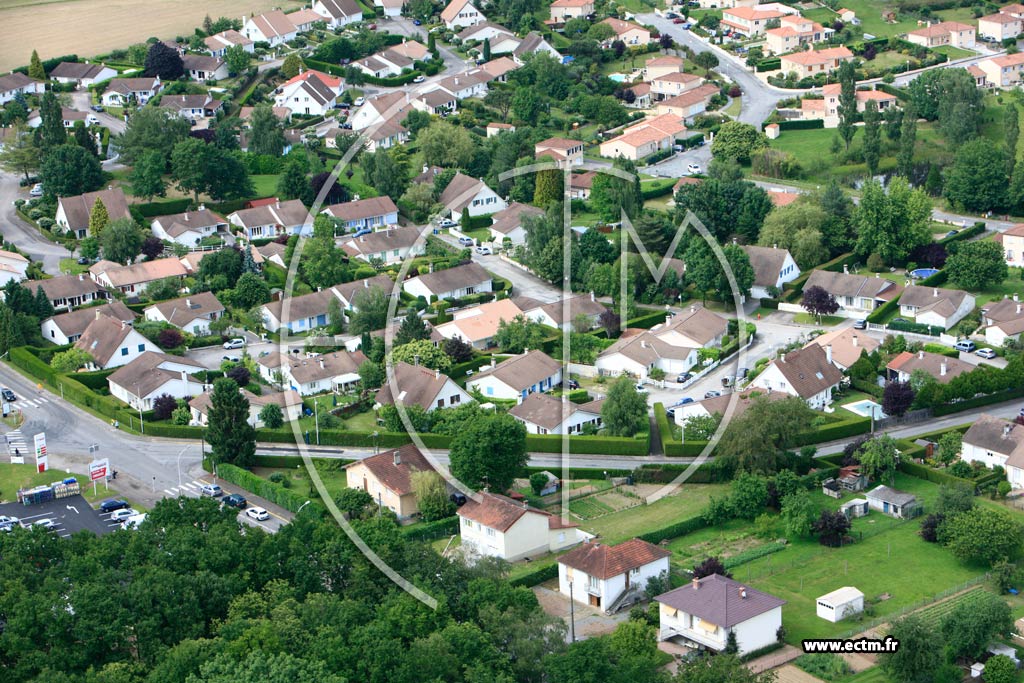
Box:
[0, 0, 300, 72]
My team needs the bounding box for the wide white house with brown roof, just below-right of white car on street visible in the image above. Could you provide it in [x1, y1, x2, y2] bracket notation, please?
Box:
[256, 351, 367, 396]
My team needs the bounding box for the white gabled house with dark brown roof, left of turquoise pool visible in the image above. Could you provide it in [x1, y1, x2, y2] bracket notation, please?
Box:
[753, 344, 843, 411]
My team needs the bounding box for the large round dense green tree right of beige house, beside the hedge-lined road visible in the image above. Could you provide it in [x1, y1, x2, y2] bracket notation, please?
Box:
[449, 414, 527, 494]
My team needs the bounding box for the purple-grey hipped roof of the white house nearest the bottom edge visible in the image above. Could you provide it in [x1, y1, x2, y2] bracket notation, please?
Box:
[654, 573, 785, 629]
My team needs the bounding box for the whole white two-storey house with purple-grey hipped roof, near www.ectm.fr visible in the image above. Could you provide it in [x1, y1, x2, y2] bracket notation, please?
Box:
[654, 573, 785, 656]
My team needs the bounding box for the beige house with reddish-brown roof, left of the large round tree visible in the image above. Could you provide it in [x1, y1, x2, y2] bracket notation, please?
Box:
[345, 443, 437, 519]
